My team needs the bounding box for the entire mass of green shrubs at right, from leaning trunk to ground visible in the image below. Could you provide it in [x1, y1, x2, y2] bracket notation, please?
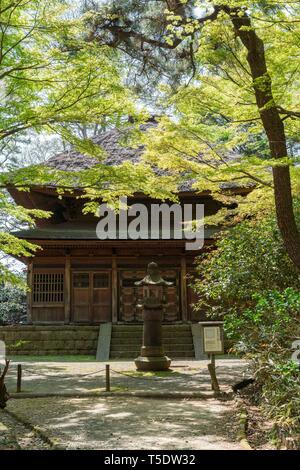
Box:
[194, 210, 300, 444]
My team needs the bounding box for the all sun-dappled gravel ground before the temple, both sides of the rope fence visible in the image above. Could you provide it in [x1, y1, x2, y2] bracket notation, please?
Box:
[0, 359, 252, 450]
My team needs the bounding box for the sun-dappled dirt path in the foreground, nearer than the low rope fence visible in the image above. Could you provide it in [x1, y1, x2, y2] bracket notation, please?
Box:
[8, 397, 246, 450]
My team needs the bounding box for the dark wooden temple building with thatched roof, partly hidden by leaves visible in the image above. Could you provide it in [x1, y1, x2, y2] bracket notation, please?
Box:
[8, 121, 241, 325]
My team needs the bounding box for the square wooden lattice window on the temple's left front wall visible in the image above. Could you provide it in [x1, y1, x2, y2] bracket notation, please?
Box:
[33, 273, 64, 304]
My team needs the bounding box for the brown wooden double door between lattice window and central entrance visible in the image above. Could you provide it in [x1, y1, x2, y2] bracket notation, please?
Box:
[71, 271, 111, 323]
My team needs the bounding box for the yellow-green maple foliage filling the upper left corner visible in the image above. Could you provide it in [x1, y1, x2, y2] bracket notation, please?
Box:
[0, 0, 134, 281]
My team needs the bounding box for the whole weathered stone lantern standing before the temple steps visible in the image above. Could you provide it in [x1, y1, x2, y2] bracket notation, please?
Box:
[134, 262, 173, 371]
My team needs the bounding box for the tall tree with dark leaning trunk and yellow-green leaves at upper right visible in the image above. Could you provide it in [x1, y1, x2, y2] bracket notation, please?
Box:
[84, 0, 300, 269]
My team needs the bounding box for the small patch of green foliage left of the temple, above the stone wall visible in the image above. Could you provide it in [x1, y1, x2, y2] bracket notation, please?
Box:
[0, 284, 26, 324]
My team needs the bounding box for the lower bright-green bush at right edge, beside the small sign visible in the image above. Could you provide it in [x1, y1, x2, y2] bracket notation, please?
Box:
[225, 288, 300, 438]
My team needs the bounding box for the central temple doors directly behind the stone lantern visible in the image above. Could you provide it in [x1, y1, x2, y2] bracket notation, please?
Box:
[119, 269, 181, 323]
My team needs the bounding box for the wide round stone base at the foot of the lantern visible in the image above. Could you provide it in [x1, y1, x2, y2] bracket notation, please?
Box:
[134, 346, 171, 371]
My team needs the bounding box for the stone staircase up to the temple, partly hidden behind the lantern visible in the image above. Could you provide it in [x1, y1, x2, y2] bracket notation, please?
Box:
[110, 324, 195, 359]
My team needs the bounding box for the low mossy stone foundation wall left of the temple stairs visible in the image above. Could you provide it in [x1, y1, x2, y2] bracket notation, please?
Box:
[0, 325, 99, 356]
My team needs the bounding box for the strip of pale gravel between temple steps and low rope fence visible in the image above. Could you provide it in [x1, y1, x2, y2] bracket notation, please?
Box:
[7, 359, 246, 392]
